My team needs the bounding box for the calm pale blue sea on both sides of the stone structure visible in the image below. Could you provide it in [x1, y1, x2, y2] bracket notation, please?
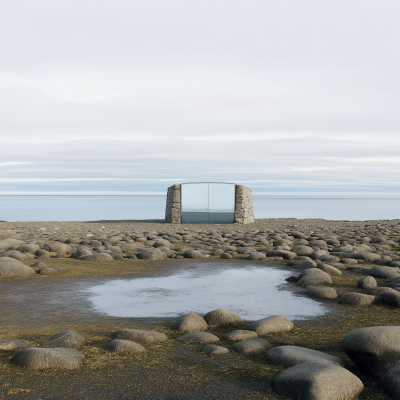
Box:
[0, 195, 400, 221]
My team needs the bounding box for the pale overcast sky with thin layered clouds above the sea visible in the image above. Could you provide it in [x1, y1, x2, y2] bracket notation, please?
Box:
[0, 0, 400, 195]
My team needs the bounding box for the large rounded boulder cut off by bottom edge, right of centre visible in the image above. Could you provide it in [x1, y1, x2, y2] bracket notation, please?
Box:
[272, 362, 364, 400]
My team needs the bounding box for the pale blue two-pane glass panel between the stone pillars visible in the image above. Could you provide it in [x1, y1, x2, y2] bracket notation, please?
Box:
[181, 182, 236, 223]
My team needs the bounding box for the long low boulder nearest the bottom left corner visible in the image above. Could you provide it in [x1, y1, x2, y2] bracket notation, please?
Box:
[11, 348, 85, 370]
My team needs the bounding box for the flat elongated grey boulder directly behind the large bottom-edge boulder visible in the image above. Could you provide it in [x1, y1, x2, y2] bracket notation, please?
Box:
[266, 346, 346, 368]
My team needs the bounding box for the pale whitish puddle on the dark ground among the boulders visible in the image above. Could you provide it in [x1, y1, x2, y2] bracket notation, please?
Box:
[88, 265, 327, 320]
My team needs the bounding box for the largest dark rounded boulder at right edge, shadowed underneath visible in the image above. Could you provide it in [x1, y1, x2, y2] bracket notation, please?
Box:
[339, 326, 400, 376]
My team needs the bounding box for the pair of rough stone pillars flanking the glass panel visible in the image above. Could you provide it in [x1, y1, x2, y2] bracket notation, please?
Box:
[165, 185, 254, 224]
